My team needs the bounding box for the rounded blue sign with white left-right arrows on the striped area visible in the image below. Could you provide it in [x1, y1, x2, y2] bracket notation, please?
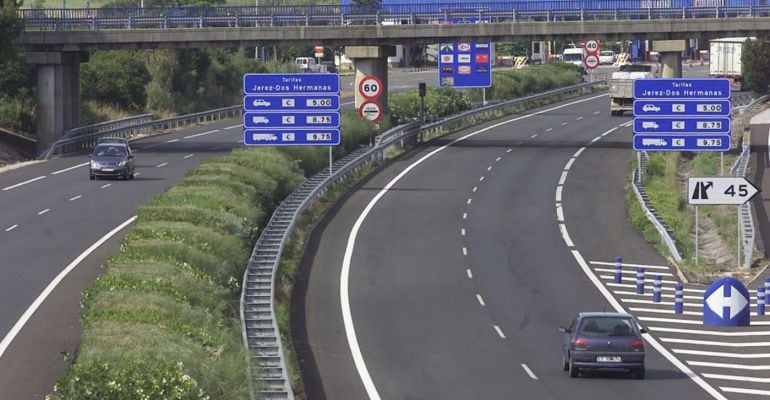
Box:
[703, 278, 751, 326]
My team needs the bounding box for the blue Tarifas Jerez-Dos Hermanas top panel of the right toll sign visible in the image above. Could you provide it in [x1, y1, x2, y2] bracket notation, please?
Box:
[634, 79, 730, 100]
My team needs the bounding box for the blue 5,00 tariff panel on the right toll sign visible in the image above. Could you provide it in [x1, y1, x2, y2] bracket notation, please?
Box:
[634, 100, 731, 117]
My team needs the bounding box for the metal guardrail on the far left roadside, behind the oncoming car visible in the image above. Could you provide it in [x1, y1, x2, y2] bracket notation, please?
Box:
[40, 104, 243, 160]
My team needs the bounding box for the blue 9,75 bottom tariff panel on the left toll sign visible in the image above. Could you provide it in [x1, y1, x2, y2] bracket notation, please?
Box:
[243, 129, 340, 146]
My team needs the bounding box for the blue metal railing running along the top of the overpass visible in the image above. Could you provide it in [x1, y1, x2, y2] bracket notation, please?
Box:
[19, 0, 770, 30]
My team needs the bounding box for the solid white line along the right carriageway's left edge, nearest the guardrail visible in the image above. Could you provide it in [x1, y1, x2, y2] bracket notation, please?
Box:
[340, 94, 608, 400]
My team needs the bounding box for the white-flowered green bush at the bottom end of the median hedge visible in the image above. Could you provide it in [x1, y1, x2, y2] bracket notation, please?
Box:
[50, 358, 209, 400]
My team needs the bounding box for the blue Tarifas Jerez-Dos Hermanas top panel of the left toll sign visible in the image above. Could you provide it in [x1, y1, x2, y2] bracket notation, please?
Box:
[243, 74, 340, 95]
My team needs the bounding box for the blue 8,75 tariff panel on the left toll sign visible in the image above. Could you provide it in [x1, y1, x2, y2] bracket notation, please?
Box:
[243, 111, 340, 129]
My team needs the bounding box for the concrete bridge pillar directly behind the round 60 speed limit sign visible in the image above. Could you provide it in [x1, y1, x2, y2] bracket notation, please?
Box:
[345, 46, 396, 114]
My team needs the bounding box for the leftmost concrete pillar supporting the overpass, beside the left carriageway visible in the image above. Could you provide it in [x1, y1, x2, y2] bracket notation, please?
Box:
[27, 52, 88, 154]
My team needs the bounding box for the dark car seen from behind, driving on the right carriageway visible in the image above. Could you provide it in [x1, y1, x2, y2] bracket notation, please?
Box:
[559, 312, 646, 379]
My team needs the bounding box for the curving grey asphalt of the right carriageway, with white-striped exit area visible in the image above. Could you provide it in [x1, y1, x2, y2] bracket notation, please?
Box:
[293, 90, 770, 399]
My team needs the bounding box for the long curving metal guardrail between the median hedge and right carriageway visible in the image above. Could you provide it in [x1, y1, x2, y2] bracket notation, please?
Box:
[240, 82, 602, 399]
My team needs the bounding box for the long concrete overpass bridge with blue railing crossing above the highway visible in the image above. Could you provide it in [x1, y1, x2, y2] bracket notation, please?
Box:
[17, 0, 770, 150]
